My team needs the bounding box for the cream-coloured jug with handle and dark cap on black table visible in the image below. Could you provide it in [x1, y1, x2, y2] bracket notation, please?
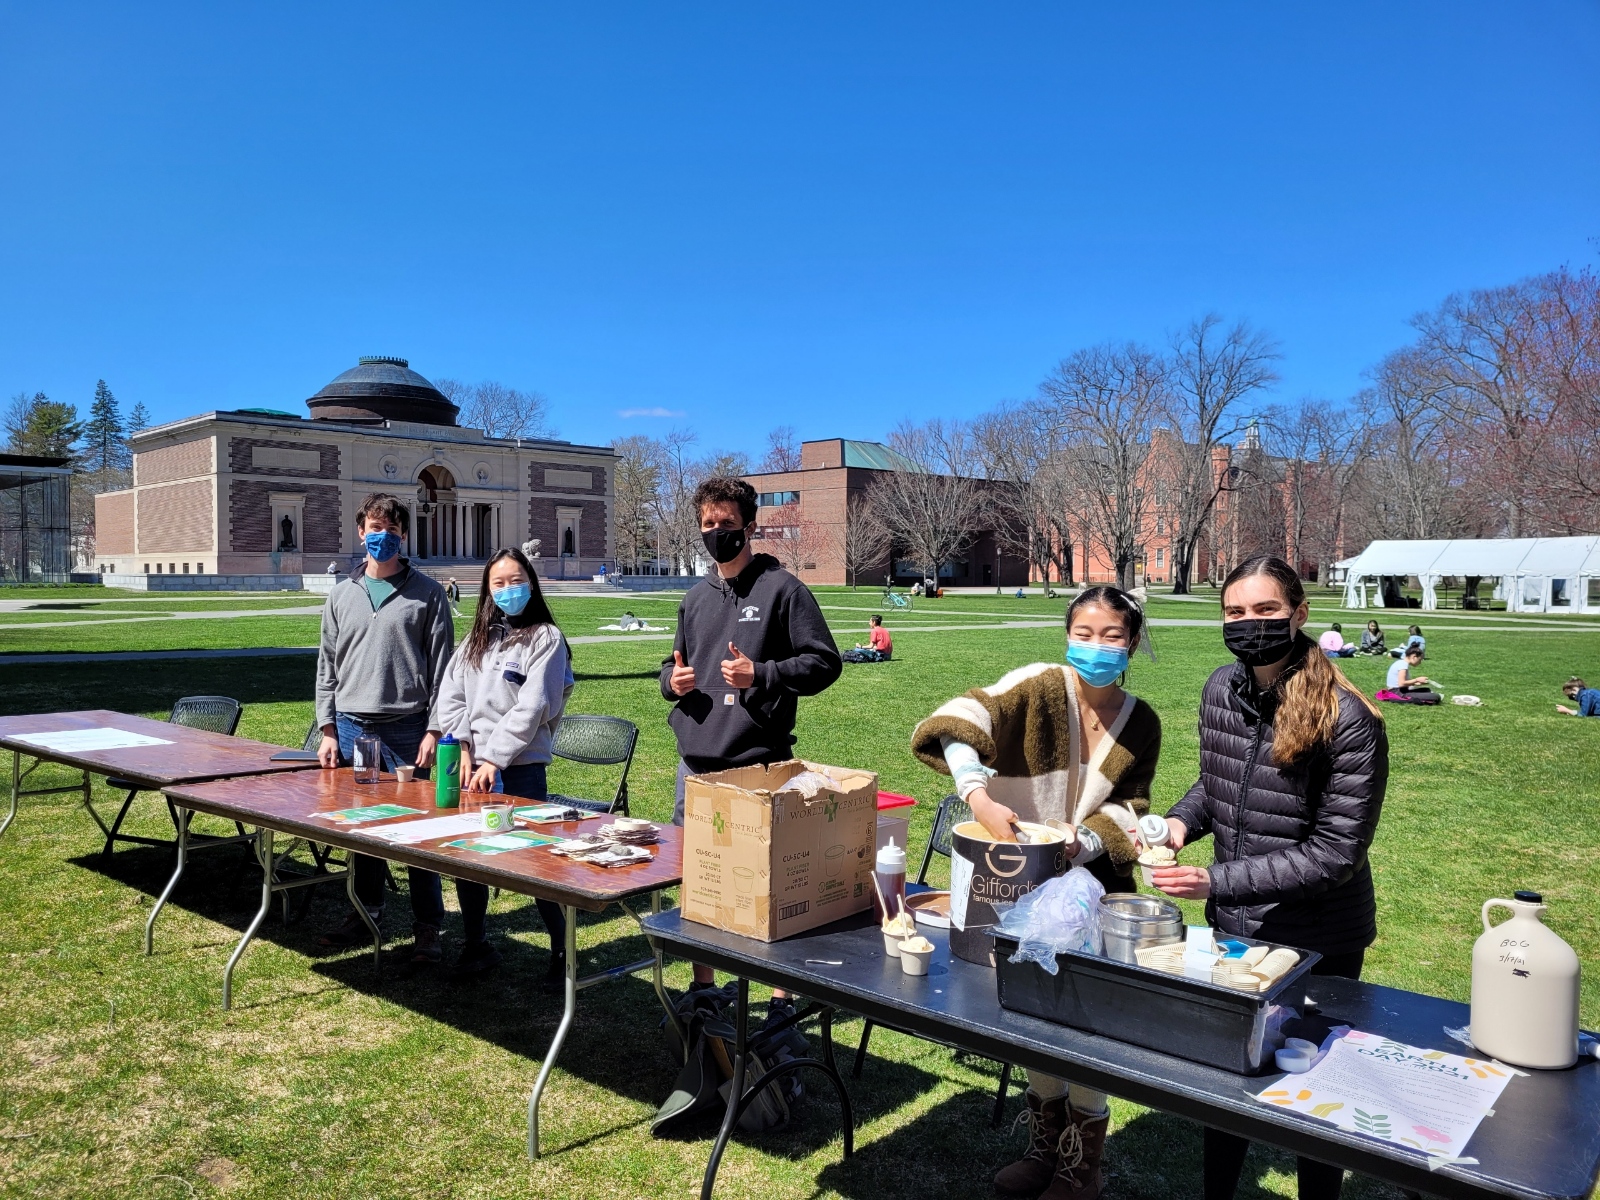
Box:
[1470, 891, 1579, 1070]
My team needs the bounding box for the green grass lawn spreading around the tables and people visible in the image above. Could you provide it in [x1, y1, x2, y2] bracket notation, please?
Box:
[0, 589, 1600, 1200]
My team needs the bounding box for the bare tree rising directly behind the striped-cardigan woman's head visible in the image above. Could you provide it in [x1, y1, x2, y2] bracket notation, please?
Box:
[1038, 342, 1168, 587]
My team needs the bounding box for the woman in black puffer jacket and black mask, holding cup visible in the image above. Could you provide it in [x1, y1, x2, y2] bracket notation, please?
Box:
[1155, 555, 1389, 1200]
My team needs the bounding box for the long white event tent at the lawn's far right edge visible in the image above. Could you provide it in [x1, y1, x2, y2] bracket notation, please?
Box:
[1344, 534, 1600, 613]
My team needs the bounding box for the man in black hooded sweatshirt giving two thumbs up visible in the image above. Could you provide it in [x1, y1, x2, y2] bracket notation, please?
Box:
[661, 477, 843, 1021]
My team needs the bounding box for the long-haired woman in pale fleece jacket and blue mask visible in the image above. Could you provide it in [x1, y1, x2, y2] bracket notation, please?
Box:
[438, 549, 573, 982]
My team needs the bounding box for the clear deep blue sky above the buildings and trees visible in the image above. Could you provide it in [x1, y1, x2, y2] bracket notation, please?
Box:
[0, 2, 1600, 451]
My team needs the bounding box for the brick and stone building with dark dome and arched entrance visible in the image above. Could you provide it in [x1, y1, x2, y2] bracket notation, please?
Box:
[94, 357, 618, 587]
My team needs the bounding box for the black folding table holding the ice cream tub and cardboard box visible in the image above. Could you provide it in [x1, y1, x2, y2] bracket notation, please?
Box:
[643, 909, 1600, 1200]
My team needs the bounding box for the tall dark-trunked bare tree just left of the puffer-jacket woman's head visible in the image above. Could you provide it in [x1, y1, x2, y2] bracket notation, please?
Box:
[1150, 312, 1280, 594]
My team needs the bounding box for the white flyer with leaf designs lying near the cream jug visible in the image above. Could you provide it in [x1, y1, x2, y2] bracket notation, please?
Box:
[1256, 1030, 1510, 1157]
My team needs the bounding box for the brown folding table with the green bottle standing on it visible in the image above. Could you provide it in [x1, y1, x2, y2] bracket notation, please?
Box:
[164, 768, 683, 1158]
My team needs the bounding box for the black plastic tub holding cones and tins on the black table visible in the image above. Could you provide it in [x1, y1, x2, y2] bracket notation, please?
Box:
[994, 934, 1322, 1075]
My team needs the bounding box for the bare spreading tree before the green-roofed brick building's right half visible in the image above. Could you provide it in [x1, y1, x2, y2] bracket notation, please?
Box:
[866, 422, 986, 581]
